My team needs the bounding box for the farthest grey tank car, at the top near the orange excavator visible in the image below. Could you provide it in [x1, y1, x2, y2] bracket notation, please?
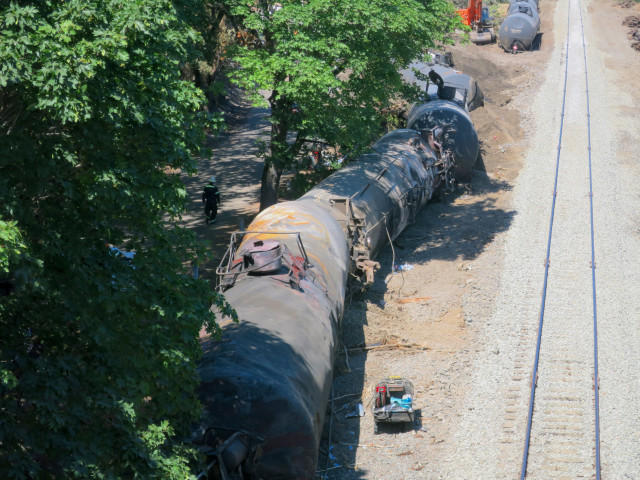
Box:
[499, 0, 540, 53]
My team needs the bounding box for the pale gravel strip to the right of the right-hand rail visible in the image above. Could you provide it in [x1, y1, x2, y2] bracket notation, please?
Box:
[583, 0, 640, 479]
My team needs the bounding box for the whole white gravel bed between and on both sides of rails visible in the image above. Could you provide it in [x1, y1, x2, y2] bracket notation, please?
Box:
[434, 0, 640, 479]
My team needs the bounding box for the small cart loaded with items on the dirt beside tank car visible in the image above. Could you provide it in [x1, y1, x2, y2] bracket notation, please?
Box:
[373, 377, 415, 434]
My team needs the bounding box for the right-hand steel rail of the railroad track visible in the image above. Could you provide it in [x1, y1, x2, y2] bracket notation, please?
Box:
[578, 0, 600, 480]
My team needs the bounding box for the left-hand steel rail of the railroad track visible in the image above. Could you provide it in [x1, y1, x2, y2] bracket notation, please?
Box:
[520, 0, 571, 474]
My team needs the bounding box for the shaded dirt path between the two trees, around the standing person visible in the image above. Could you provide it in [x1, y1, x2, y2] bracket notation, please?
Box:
[183, 90, 269, 278]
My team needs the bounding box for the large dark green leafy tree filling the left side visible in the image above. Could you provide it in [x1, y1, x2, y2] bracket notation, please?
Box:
[0, 0, 229, 478]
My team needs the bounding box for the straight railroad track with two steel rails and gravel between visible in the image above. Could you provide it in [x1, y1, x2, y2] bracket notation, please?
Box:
[520, 0, 600, 480]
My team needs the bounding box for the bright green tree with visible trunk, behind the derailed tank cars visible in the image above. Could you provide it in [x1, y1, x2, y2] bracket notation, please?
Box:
[221, 0, 460, 209]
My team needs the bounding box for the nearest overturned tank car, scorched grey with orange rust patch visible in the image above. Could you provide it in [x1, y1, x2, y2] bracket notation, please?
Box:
[200, 199, 349, 479]
